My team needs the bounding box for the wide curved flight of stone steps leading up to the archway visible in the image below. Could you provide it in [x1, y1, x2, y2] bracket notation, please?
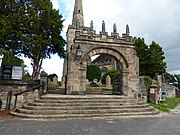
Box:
[10, 94, 159, 119]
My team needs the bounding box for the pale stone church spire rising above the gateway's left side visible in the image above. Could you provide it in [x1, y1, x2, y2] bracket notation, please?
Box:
[72, 0, 84, 27]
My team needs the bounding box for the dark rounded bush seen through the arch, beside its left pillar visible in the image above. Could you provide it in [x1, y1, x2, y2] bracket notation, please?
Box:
[86, 65, 101, 81]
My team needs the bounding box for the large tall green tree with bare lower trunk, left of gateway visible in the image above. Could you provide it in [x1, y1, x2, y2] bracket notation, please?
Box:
[0, 0, 66, 79]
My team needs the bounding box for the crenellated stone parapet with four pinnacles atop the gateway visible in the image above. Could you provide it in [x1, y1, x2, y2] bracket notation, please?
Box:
[69, 21, 134, 45]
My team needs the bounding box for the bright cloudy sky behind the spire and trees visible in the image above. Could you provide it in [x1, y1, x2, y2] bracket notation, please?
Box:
[25, 0, 180, 80]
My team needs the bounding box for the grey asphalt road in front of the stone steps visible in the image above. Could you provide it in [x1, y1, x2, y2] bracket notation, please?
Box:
[0, 105, 180, 135]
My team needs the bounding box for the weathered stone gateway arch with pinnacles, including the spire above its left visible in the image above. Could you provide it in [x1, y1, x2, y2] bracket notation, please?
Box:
[62, 0, 139, 96]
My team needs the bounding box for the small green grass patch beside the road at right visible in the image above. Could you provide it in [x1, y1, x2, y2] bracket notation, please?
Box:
[149, 98, 180, 112]
